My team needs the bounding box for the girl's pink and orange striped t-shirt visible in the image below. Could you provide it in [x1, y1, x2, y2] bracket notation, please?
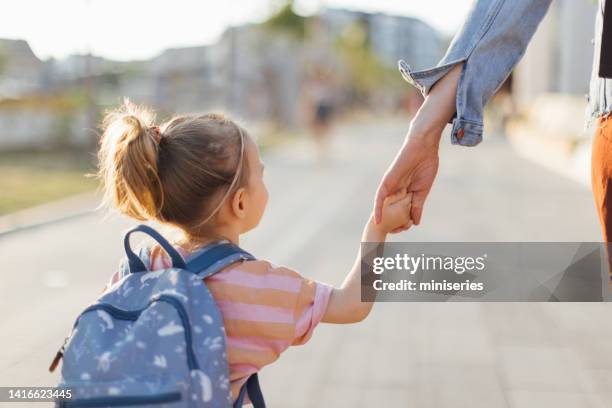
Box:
[109, 245, 332, 400]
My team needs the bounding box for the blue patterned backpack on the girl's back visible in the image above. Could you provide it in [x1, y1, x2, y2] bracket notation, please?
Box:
[49, 225, 265, 408]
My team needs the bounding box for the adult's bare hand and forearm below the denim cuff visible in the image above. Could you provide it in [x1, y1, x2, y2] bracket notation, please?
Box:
[374, 64, 463, 226]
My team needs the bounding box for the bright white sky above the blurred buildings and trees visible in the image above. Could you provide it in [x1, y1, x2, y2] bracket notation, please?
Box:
[0, 0, 472, 60]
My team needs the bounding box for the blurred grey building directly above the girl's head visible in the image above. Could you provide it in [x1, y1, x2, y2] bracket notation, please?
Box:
[130, 24, 301, 124]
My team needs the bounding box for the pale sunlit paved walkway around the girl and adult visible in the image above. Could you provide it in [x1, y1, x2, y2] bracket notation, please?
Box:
[0, 116, 612, 408]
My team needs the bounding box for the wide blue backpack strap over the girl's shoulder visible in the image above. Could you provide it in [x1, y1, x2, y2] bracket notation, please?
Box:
[185, 241, 255, 278]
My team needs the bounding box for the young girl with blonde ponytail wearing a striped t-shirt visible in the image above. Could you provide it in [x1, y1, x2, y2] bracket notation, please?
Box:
[99, 100, 411, 401]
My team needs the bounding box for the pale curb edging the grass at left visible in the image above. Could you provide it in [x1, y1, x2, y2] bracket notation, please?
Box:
[0, 191, 101, 238]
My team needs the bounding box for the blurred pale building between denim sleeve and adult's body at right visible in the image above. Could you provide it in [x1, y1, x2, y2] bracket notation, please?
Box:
[506, 0, 598, 185]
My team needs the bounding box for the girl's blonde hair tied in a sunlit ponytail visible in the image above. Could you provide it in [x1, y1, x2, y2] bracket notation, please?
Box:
[98, 99, 249, 236]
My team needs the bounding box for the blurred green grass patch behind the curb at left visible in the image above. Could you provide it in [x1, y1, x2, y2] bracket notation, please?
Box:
[0, 151, 98, 215]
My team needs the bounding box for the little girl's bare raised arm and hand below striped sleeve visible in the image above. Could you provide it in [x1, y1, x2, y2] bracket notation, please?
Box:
[321, 192, 412, 323]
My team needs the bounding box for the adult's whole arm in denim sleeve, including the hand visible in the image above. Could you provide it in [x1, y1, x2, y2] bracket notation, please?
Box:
[374, 0, 551, 224]
